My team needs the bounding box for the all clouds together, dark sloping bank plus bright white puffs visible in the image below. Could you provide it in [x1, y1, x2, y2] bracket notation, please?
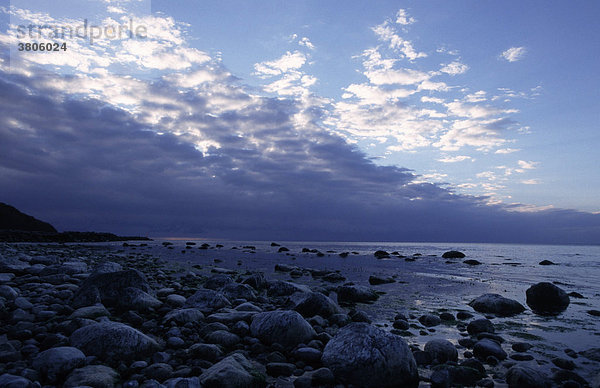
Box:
[0, 5, 600, 243]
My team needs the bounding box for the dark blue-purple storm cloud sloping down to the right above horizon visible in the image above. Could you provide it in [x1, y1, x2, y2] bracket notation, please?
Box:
[0, 66, 600, 243]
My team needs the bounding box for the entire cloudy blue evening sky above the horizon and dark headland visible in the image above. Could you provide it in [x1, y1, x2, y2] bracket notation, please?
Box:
[0, 0, 600, 243]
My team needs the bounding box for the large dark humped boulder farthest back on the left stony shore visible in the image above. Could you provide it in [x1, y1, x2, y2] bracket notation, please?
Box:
[71, 269, 152, 309]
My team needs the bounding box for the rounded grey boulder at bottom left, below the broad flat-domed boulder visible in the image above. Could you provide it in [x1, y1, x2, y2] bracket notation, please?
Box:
[33, 346, 85, 383]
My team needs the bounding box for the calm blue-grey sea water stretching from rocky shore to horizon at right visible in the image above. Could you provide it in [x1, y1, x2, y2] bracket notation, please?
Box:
[136, 240, 600, 378]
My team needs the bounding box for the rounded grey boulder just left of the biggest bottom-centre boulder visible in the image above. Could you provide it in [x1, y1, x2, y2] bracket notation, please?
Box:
[250, 310, 316, 347]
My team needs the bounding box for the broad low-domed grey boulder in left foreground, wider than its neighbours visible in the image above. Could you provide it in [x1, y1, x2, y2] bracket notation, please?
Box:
[69, 321, 158, 360]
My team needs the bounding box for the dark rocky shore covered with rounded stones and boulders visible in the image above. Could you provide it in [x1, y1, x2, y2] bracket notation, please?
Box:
[0, 243, 600, 388]
